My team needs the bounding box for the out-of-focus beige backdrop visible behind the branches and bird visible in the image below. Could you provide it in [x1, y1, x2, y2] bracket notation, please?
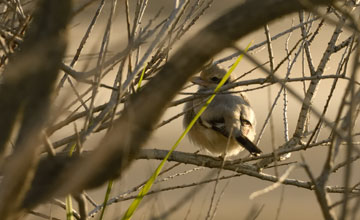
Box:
[18, 0, 360, 220]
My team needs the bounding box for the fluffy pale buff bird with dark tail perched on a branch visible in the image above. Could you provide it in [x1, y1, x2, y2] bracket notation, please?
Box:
[183, 63, 262, 158]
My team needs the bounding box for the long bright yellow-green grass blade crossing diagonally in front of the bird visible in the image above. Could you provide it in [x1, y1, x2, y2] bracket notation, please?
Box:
[122, 43, 251, 220]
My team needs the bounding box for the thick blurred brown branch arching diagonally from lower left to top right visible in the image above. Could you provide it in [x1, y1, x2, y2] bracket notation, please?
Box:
[21, 0, 331, 211]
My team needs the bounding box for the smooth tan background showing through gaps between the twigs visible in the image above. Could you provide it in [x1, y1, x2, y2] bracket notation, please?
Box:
[28, 0, 359, 220]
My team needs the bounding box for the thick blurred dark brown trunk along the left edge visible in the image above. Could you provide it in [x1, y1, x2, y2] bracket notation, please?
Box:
[0, 0, 71, 219]
